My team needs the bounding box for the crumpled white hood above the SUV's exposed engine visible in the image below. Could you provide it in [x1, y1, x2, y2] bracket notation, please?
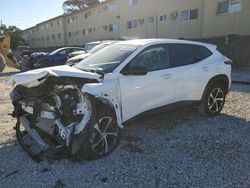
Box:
[11, 65, 101, 86]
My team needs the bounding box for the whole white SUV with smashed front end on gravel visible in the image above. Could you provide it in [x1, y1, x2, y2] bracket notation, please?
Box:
[10, 39, 231, 159]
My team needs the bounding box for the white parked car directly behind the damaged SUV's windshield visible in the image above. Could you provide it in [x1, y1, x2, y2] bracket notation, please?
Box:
[66, 41, 118, 65]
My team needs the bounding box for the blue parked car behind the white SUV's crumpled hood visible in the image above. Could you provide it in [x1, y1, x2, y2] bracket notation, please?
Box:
[34, 47, 83, 68]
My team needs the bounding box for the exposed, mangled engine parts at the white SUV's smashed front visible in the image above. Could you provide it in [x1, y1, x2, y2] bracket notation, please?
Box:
[10, 80, 92, 161]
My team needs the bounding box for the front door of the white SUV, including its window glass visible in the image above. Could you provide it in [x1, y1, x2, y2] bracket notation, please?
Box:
[119, 45, 176, 121]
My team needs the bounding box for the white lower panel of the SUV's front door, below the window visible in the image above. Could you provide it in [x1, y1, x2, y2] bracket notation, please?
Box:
[119, 69, 176, 121]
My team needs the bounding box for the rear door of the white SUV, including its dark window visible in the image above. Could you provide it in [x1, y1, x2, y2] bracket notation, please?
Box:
[169, 44, 215, 102]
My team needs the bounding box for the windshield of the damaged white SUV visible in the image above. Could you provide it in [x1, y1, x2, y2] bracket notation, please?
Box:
[75, 44, 138, 73]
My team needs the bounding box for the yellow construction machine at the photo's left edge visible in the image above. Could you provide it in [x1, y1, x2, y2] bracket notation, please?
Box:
[0, 35, 21, 72]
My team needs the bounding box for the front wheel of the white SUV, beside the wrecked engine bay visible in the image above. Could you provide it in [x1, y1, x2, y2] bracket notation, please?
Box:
[85, 110, 121, 160]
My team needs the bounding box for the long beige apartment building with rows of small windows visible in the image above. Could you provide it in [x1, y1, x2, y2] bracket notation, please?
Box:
[23, 0, 250, 48]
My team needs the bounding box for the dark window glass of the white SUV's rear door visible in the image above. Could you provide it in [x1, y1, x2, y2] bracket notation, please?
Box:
[169, 44, 195, 67]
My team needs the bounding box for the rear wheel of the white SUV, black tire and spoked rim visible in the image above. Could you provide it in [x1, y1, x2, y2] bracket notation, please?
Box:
[198, 83, 226, 117]
